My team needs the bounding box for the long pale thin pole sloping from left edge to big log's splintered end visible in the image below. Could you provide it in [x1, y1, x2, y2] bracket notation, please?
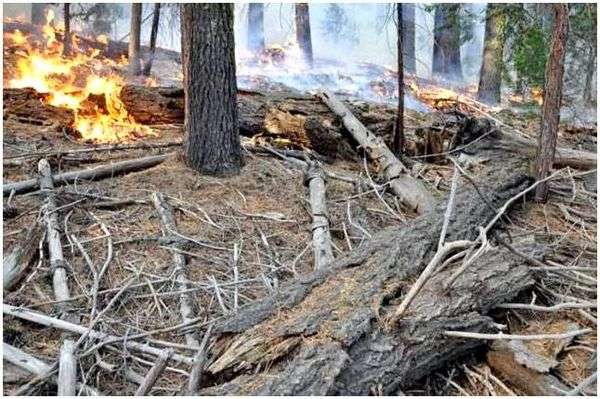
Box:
[2, 303, 193, 365]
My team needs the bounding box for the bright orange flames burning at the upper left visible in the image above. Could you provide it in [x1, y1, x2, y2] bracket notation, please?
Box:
[4, 10, 154, 143]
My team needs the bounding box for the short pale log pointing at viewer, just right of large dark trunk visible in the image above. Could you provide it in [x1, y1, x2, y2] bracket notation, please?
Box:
[306, 162, 333, 269]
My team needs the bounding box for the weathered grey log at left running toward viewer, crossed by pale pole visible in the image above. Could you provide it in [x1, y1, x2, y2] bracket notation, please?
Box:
[38, 159, 77, 396]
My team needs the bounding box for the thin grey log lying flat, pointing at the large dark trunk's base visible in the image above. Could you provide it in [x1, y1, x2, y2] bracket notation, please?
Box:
[2, 154, 171, 196]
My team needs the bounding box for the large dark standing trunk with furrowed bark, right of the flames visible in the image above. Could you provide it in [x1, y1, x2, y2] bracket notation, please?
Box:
[181, 3, 243, 175]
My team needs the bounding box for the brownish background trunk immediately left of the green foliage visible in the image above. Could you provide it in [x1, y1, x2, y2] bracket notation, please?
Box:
[477, 3, 506, 105]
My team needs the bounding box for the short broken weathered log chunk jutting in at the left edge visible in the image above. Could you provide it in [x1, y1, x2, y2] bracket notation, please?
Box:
[2, 221, 43, 292]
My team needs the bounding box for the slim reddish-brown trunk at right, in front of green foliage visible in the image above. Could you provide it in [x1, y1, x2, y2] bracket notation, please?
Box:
[535, 4, 569, 202]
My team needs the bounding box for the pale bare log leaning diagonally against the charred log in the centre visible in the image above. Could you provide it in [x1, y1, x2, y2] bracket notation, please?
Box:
[318, 91, 434, 213]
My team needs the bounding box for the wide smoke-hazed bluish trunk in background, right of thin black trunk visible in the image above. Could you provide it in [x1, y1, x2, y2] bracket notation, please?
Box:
[432, 4, 462, 81]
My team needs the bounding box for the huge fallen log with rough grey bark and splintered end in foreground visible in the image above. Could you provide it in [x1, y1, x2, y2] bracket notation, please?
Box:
[195, 170, 534, 395]
